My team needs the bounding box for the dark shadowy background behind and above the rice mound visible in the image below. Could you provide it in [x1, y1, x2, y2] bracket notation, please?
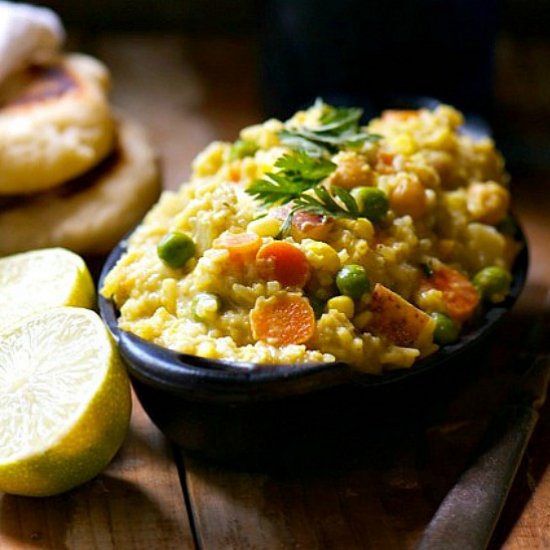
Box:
[22, 0, 550, 170]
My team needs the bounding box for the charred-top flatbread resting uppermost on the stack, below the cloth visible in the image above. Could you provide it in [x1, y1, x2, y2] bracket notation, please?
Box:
[0, 54, 115, 195]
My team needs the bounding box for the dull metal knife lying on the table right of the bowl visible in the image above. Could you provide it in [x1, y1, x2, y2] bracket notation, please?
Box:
[417, 324, 550, 550]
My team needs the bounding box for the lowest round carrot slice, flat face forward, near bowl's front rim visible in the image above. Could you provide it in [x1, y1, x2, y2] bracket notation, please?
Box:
[250, 294, 315, 346]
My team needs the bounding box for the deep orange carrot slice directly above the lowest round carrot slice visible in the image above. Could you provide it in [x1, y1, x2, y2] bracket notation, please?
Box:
[256, 241, 310, 288]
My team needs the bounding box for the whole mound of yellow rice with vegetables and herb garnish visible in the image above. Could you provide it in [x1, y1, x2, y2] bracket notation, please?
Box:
[101, 101, 518, 373]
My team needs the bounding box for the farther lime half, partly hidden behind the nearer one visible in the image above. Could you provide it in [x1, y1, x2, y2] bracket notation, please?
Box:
[0, 248, 95, 328]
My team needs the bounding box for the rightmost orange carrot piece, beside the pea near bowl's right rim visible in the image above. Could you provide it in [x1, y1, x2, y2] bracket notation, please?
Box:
[421, 265, 479, 321]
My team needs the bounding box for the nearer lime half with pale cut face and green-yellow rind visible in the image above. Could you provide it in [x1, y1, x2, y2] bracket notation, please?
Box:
[0, 307, 131, 496]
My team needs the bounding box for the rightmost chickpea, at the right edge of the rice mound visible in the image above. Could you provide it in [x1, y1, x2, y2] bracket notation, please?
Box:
[467, 181, 510, 225]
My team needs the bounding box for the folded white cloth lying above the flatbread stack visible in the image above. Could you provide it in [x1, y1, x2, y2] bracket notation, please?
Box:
[0, 1, 65, 82]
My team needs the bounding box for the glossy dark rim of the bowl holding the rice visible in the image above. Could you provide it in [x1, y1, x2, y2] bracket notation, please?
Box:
[98, 222, 529, 401]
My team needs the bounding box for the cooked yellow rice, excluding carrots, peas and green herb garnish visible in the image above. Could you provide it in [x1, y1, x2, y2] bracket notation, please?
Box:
[101, 103, 516, 373]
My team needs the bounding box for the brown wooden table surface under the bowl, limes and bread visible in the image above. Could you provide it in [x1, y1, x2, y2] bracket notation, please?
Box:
[0, 31, 550, 550]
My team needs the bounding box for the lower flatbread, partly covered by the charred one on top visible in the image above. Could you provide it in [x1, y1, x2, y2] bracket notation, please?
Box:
[0, 118, 161, 255]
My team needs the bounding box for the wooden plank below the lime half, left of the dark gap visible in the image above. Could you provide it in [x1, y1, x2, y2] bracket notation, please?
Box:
[0, 400, 194, 550]
